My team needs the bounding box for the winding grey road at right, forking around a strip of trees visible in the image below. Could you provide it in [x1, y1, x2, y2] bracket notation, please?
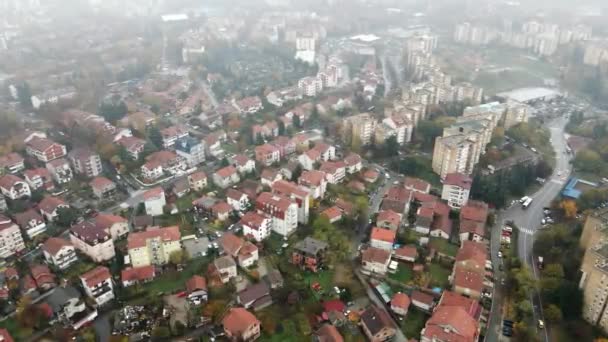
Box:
[486, 118, 571, 342]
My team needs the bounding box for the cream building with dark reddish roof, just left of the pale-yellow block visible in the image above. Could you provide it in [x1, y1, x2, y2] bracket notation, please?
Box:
[70, 222, 116, 263]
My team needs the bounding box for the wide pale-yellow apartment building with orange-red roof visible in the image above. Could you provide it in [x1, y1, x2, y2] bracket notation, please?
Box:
[127, 226, 182, 267]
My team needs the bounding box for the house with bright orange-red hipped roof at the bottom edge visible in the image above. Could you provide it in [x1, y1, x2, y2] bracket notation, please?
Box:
[222, 308, 261, 342]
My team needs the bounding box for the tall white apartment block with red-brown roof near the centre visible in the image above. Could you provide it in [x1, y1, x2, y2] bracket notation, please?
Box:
[256, 192, 298, 236]
